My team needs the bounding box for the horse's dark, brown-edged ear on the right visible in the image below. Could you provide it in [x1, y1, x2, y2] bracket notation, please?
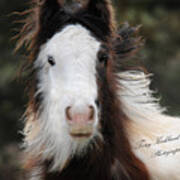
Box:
[86, 0, 115, 36]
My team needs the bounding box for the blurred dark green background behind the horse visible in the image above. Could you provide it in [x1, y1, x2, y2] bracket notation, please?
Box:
[0, 0, 180, 180]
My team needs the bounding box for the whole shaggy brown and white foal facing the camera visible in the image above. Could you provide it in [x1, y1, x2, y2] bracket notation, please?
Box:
[17, 0, 180, 180]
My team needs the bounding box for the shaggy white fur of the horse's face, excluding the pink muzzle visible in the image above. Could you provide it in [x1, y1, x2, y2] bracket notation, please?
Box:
[25, 25, 100, 171]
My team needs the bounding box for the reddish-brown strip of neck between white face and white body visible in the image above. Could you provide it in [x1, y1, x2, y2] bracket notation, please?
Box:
[95, 43, 149, 180]
